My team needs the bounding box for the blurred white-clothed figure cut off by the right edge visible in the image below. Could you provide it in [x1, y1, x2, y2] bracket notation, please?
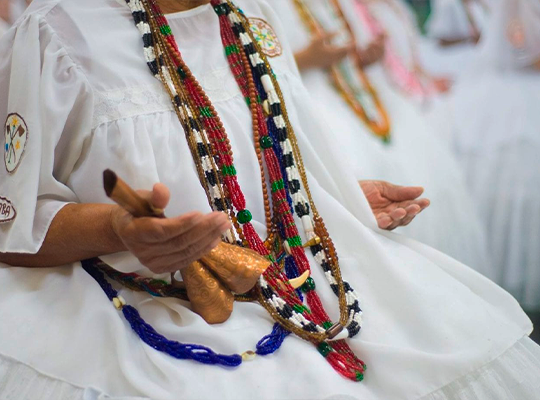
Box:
[453, 0, 540, 310]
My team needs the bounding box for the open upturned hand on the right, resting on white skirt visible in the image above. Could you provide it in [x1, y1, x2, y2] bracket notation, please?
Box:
[359, 181, 430, 231]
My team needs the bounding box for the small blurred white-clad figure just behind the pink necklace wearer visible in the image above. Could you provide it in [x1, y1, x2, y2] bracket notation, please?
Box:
[424, 0, 492, 78]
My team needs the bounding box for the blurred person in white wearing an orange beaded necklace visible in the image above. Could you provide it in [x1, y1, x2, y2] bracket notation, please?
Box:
[275, 0, 491, 276]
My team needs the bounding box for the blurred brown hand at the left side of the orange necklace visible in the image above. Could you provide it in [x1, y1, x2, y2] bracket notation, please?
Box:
[294, 33, 354, 71]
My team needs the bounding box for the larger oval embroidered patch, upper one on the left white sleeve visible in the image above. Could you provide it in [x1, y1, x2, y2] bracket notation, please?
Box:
[4, 113, 28, 174]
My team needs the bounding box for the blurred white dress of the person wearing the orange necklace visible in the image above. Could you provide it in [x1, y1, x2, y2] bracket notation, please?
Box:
[275, 0, 491, 277]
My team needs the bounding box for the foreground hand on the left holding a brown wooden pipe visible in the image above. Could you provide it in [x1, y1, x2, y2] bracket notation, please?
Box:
[111, 183, 231, 274]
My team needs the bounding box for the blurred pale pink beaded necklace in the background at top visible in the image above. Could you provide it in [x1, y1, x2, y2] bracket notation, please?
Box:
[354, 0, 437, 99]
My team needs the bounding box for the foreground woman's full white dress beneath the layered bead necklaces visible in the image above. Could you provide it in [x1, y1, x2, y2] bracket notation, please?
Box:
[0, 0, 540, 400]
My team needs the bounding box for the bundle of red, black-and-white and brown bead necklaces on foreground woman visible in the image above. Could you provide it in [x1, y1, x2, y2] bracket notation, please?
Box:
[89, 0, 365, 381]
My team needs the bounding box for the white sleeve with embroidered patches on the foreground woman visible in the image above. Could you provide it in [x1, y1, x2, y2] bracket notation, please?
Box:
[0, 14, 93, 253]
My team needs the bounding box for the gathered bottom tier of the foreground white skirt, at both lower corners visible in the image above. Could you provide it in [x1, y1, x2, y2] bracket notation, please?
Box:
[0, 338, 540, 400]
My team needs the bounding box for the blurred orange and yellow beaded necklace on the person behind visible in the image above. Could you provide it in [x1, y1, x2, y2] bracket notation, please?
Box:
[293, 0, 390, 143]
